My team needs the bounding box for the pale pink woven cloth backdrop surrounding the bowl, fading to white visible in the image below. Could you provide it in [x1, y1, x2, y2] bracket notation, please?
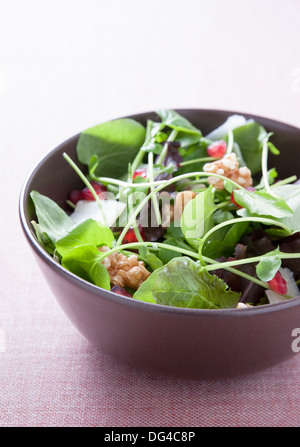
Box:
[0, 0, 300, 427]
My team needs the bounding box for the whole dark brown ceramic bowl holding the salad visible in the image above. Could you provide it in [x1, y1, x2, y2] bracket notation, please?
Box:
[20, 109, 300, 379]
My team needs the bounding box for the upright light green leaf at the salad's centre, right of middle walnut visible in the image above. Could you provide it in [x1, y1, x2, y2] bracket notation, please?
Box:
[181, 186, 217, 246]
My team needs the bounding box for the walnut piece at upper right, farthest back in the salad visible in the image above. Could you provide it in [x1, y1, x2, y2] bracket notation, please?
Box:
[203, 152, 253, 189]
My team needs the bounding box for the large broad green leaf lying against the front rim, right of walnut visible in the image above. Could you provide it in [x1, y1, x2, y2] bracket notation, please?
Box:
[152, 257, 240, 309]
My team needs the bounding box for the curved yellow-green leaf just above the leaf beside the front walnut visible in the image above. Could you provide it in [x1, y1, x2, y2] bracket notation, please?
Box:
[56, 219, 114, 256]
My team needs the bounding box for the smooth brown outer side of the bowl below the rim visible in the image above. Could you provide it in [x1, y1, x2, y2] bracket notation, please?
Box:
[27, 250, 300, 379]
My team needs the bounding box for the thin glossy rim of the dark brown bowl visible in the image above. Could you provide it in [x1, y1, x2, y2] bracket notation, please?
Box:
[18, 108, 300, 317]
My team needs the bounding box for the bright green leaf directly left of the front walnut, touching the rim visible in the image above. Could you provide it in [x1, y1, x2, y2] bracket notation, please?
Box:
[61, 244, 110, 290]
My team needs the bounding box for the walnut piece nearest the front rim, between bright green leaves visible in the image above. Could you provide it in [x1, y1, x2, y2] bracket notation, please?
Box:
[99, 246, 151, 290]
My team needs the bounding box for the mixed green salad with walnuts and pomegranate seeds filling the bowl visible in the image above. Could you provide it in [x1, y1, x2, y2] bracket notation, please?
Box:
[30, 110, 300, 309]
